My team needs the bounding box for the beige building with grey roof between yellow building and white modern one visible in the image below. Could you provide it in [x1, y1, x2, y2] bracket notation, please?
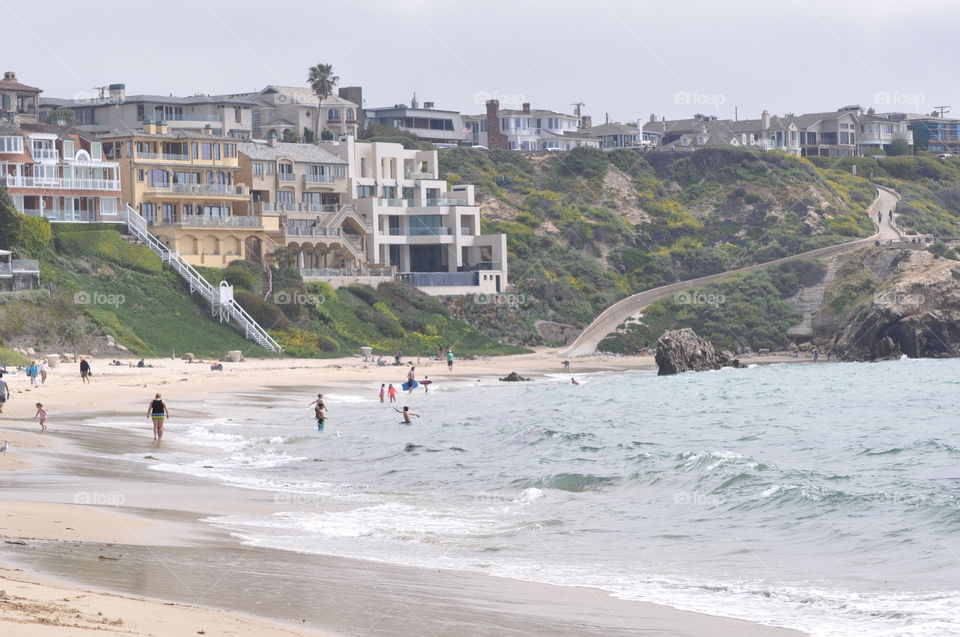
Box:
[238, 139, 372, 277]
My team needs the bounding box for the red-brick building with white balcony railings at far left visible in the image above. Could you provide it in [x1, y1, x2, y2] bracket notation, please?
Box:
[0, 121, 123, 222]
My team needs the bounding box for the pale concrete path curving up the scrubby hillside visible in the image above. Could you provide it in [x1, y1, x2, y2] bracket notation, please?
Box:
[562, 186, 901, 356]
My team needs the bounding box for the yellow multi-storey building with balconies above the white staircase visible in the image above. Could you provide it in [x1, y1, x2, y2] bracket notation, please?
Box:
[101, 122, 279, 267]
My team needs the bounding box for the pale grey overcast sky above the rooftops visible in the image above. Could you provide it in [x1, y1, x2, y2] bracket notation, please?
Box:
[7, 0, 960, 123]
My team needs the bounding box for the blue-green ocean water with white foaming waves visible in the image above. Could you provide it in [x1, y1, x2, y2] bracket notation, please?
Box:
[116, 360, 960, 637]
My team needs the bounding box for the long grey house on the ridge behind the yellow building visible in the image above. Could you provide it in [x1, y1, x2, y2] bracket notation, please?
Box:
[40, 84, 256, 139]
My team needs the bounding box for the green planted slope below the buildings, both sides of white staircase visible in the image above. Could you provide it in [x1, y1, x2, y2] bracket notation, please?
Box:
[0, 191, 524, 364]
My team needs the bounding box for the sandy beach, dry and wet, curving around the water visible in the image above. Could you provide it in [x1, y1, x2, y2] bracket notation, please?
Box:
[0, 350, 800, 637]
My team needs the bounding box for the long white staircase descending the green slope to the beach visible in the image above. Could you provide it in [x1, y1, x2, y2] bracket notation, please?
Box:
[125, 205, 283, 354]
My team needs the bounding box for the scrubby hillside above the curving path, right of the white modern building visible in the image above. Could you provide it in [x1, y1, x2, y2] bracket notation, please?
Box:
[440, 148, 875, 344]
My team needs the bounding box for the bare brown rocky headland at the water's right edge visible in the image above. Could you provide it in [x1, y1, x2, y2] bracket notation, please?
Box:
[833, 251, 960, 361]
